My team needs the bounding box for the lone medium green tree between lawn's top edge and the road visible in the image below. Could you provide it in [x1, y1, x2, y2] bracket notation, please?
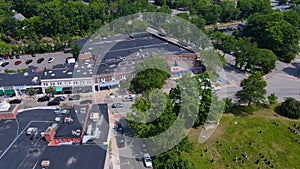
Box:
[235, 72, 267, 106]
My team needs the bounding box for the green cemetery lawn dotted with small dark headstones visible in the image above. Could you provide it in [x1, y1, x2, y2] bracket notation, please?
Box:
[182, 106, 300, 169]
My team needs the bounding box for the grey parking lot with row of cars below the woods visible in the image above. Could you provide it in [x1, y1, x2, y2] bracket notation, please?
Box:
[0, 52, 72, 73]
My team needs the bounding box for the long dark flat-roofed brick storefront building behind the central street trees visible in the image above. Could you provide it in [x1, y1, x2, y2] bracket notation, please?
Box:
[82, 32, 204, 91]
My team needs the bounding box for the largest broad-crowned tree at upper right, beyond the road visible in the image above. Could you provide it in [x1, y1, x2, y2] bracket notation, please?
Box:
[244, 12, 300, 62]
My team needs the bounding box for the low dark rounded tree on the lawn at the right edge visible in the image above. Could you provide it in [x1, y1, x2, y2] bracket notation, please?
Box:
[275, 97, 300, 119]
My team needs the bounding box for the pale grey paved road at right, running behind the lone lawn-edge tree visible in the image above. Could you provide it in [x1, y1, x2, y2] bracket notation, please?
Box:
[217, 54, 300, 101]
